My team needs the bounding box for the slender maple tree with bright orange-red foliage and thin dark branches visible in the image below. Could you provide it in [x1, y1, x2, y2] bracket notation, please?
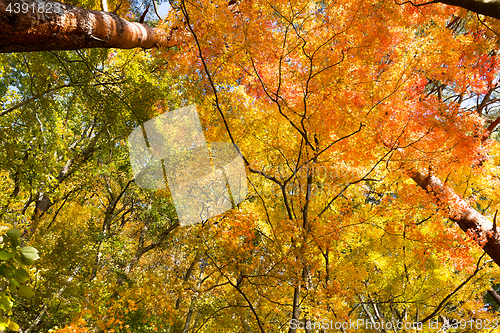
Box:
[160, 2, 496, 331]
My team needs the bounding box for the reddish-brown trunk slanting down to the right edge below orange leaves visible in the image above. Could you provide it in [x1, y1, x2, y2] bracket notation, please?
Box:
[410, 172, 500, 266]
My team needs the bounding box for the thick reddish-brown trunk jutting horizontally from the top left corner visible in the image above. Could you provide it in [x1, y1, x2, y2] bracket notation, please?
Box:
[0, 0, 163, 53]
